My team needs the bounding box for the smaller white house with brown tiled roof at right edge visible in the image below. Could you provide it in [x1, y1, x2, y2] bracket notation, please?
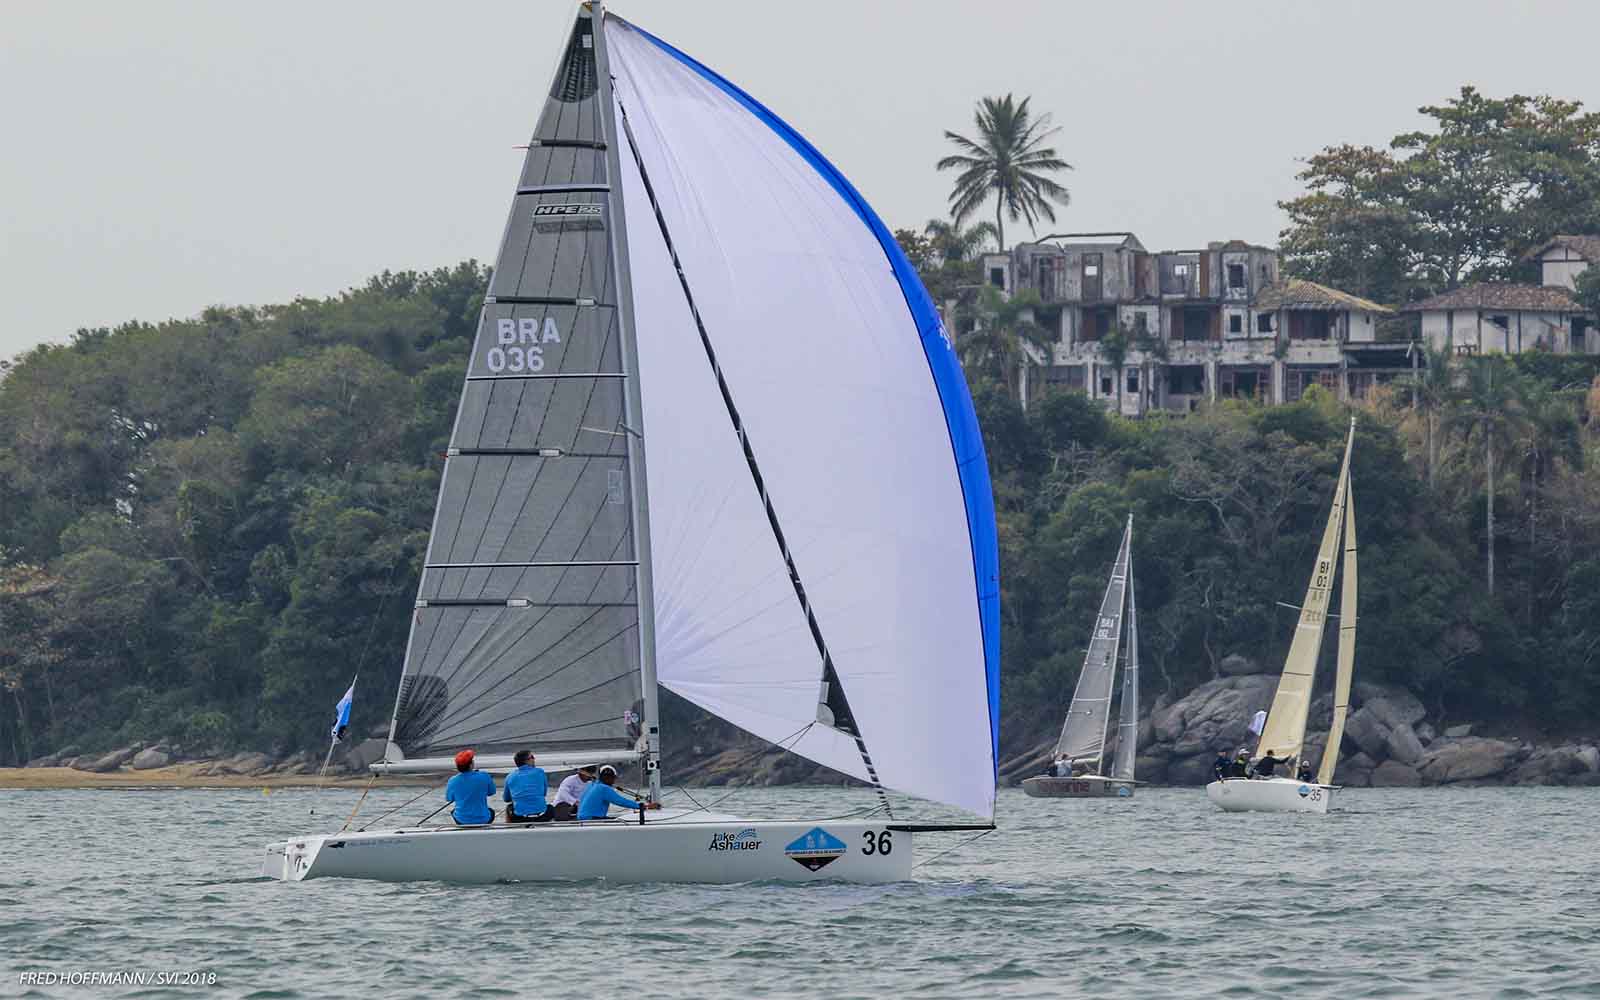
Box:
[1405, 237, 1600, 354]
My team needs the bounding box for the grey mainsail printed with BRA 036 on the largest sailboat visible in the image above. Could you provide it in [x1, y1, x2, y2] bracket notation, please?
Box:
[390, 14, 656, 758]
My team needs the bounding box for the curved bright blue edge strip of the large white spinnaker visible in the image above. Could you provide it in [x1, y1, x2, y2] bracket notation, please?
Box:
[620, 14, 1000, 780]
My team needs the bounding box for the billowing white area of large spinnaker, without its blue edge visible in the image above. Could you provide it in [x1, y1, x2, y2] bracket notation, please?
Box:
[606, 18, 995, 816]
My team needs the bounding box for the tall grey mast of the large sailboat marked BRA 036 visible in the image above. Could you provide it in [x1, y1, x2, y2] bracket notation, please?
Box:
[589, 0, 661, 802]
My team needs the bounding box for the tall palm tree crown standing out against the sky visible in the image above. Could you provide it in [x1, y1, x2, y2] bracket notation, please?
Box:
[939, 94, 1072, 251]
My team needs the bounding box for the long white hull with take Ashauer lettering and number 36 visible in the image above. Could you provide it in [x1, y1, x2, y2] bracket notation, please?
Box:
[261, 813, 912, 883]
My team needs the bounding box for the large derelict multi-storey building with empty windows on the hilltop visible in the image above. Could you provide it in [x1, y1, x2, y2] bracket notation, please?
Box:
[984, 232, 1418, 416]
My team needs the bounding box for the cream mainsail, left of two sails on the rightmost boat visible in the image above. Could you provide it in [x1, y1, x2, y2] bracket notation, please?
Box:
[1256, 419, 1355, 758]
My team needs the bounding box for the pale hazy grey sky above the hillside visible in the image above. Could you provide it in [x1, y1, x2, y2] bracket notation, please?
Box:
[0, 0, 1600, 357]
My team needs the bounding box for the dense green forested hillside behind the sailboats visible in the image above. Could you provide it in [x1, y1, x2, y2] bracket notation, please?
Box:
[9, 262, 1600, 762]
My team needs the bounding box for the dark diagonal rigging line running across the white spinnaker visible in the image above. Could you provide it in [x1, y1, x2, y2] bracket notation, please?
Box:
[613, 87, 894, 818]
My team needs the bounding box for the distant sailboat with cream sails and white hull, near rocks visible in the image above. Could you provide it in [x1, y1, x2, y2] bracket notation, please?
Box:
[1205, 416, 1357, 813]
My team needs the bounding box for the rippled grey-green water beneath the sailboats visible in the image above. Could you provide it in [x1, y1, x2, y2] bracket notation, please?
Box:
[0, 789, 1600, 998]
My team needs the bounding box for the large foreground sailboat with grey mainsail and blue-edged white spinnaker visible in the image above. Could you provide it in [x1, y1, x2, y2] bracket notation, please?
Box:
[264, 3, 1000, 882]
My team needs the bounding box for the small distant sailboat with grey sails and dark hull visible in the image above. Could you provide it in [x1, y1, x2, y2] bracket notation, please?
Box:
[1022, 514, 1139, 798]
